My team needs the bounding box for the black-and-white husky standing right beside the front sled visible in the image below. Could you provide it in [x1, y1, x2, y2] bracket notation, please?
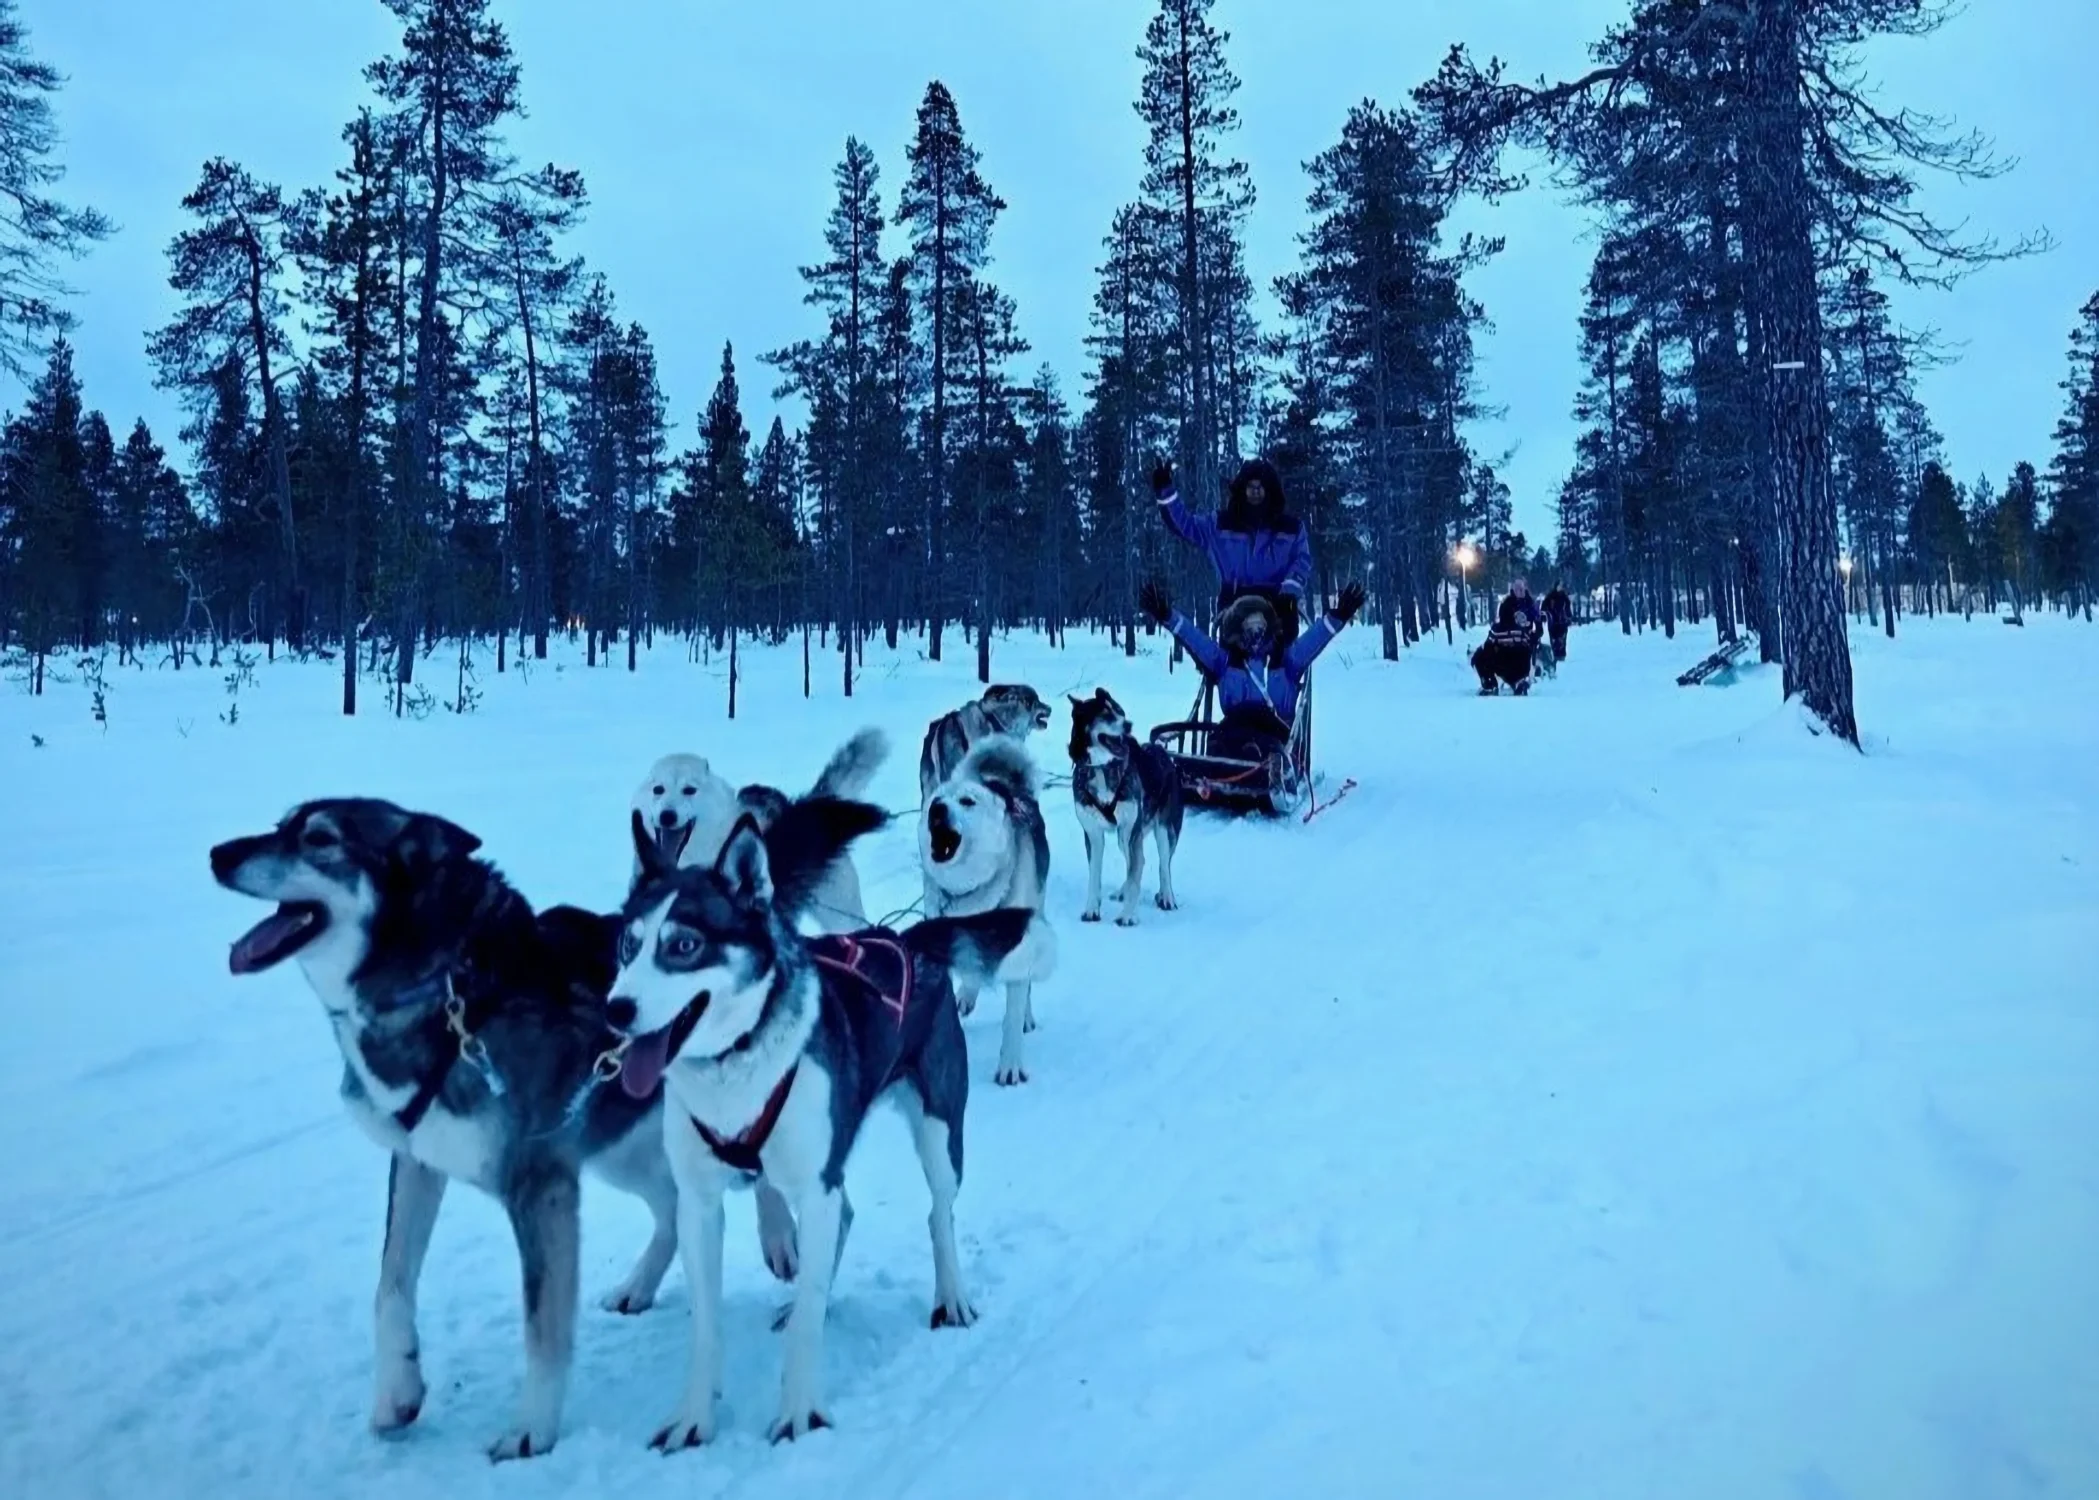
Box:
[1070, 688, 1182, 927]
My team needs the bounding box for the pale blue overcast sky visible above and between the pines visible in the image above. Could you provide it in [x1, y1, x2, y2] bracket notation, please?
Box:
[16, 0, 2099, 537]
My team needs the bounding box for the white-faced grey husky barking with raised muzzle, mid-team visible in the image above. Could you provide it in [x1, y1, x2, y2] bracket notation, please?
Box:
[919, 734, 1056, 1085]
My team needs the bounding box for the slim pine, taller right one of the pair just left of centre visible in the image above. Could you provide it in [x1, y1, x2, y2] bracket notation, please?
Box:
[896, 80, 1005, 661]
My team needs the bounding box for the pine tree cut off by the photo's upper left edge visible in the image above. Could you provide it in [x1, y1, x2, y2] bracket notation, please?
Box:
[0, 0, 113, 380]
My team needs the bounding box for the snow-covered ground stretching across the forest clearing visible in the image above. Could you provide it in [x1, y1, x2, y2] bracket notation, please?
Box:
[0, 619, 2099, 1500]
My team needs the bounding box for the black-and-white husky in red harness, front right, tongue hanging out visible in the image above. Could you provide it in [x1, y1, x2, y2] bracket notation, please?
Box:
[607, 799, 1029, 1452]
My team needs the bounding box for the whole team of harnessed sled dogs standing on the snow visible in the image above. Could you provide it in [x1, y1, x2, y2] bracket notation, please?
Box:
[212, 686, 1225, 1460]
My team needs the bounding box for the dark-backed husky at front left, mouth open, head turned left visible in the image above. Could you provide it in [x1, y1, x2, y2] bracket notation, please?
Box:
[212, 797, 678, 1460]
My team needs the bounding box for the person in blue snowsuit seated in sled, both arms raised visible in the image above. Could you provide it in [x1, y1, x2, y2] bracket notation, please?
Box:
[1138, 583, 1362, 759]
